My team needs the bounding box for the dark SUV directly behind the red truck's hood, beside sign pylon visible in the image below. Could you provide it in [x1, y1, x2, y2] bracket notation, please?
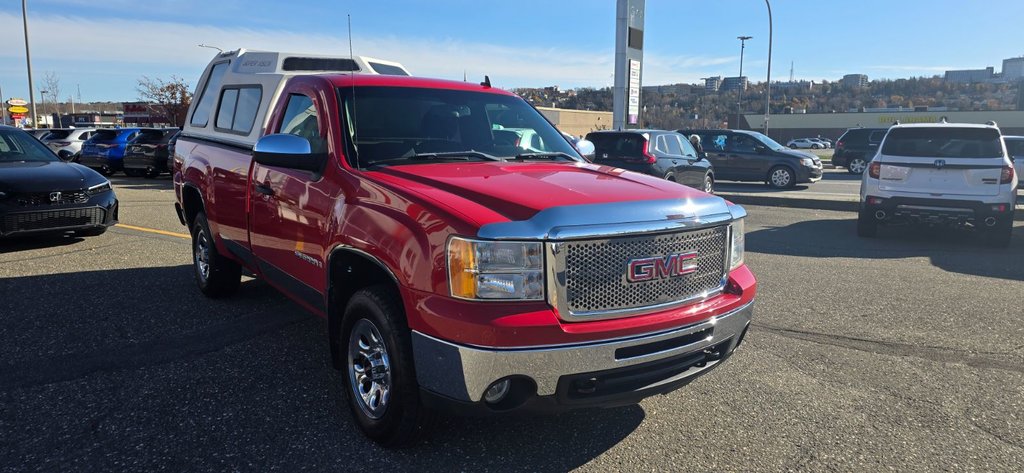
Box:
[587, 130, 715, 194]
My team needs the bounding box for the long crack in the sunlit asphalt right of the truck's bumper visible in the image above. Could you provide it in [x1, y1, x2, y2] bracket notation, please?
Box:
[751, 323, 1024, 373]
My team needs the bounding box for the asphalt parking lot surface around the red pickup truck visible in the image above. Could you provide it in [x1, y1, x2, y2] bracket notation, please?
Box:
[0, 177, 1024, 471]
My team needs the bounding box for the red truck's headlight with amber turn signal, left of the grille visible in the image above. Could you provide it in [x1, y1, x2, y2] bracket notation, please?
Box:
[447, 237, 544, 301]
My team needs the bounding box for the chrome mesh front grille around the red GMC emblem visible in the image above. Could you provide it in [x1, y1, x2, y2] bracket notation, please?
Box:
[552, 225, 729, 319]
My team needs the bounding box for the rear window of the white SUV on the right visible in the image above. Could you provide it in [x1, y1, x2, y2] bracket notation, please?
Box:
[882, 127, 1002, 158]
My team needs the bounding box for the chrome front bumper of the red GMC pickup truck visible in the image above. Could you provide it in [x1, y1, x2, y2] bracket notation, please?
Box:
[413, 302, 754, 411]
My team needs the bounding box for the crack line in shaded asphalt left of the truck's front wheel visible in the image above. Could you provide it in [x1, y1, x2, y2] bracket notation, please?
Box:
[0, 307, 313, 392]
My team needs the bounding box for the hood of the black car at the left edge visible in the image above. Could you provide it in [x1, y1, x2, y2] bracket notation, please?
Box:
[0, 161, 103, 192]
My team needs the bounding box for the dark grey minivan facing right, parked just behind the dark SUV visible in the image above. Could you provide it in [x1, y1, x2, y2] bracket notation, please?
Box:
[679, 130, 822, 188]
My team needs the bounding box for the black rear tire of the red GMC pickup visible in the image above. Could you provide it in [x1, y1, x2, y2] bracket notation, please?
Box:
[191, 212, 242, 298]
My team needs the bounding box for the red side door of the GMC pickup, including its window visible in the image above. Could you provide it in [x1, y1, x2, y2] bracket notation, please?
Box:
[249, 88, 335, 310]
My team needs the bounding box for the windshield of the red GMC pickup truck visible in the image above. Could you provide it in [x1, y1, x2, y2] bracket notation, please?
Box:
[338, 87, 581, 168]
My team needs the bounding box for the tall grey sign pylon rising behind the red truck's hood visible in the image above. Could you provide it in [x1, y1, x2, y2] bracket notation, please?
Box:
[611, 0, 645, 130]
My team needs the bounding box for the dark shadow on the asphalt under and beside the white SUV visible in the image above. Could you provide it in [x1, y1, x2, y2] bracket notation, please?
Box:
[746, 219, 1024, 281]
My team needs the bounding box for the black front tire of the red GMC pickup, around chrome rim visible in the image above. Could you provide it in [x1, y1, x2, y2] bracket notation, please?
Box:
[338, 286, 436, 447]
